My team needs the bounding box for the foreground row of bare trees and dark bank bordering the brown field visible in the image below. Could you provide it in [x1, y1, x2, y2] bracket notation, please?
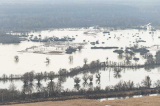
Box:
[0, 76, 160, 103]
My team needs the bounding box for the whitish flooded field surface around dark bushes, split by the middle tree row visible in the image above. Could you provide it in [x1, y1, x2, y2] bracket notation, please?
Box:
[0, 28, 160, 90]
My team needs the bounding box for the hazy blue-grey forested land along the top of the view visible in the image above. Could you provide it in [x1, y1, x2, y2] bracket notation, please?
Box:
[0, 0, 160, 30]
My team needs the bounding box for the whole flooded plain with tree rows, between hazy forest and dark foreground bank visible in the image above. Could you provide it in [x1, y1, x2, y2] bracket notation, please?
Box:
[0, 27, 160, 101]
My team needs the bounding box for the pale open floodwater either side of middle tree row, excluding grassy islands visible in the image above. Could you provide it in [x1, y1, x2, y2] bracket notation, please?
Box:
[0, 29, 160, 90]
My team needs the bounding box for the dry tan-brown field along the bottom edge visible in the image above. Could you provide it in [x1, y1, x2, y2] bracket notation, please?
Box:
[2, 96, 160, 106]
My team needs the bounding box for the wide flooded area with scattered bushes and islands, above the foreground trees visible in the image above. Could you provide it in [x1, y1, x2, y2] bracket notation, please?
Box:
[0, 27, 160, 91]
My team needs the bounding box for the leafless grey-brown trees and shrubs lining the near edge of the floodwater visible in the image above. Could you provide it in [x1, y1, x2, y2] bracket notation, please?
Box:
[0, 76, 160, 102]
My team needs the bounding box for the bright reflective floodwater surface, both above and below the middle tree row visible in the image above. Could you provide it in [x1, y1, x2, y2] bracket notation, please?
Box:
[0, 29, 160, 92]
